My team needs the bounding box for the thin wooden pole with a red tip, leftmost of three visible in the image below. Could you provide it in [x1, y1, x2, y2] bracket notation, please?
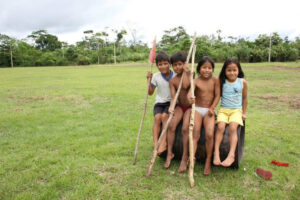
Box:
[133, 37, 156, 165]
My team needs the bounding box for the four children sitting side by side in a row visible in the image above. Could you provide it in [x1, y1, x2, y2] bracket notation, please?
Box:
[147, 52, 248, 175]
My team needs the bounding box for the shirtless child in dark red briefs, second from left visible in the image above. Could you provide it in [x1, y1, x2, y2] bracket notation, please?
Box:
[164, 52, 191, 172]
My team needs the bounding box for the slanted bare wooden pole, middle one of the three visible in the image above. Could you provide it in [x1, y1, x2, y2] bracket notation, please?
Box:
[146, 33, 196, 177]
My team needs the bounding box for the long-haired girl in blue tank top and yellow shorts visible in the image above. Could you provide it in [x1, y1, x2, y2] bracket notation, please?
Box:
[213, 59, 248, 167]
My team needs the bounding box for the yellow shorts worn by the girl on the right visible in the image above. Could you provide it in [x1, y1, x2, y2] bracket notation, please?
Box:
[217, 107, 244, 126]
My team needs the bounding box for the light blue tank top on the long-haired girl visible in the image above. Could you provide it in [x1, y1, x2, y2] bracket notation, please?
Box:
[221, 78, 243, 109]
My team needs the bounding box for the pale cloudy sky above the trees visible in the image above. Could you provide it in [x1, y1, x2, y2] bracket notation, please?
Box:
[0, 0, 300, 44]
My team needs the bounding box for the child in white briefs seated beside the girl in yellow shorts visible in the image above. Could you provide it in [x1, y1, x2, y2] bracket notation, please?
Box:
[189, 56, 220, 175]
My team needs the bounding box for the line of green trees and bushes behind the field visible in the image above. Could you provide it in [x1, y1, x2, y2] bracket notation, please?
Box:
[0, 26, 300, 67]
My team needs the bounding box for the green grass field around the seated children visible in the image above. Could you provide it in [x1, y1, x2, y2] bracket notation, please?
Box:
[0, 63, 300, 199]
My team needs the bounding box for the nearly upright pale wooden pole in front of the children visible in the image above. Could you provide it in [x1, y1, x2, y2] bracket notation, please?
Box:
[189, 45, 196, 187]
